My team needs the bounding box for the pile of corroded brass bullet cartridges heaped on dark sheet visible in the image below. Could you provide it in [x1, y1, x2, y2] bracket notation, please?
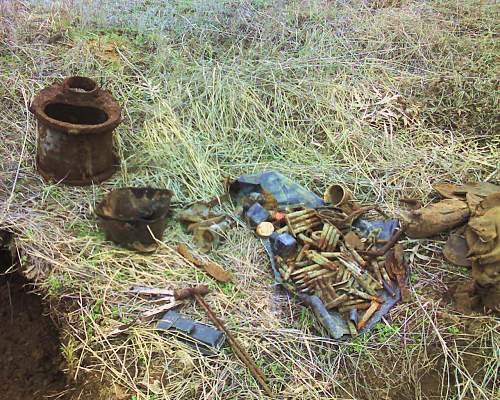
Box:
[276, 208, 395, 336]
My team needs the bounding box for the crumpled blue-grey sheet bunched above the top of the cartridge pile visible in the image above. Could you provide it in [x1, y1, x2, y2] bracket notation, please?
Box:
[228, 171, 324, 208]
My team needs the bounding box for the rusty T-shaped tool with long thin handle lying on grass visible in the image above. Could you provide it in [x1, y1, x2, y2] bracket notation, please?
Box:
[174, 285, 274, 397]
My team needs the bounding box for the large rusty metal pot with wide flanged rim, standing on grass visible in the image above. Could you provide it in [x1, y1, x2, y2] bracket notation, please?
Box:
[30, 76, 121, 186]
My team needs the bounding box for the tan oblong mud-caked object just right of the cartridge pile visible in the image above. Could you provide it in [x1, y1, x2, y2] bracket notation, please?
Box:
[403, 199, 470, 238]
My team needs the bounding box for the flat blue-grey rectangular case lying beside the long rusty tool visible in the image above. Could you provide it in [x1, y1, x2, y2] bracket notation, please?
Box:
[157, 310, 226, 356]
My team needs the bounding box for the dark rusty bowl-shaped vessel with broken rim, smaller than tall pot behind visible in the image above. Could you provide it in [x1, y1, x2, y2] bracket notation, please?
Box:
[96, 188, 173, 253]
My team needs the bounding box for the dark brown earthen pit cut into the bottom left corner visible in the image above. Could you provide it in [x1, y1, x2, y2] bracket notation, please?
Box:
[0, 245, 68, 400]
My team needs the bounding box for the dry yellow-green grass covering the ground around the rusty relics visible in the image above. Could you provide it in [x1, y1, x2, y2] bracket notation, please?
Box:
[0, 0, 500, 400]
